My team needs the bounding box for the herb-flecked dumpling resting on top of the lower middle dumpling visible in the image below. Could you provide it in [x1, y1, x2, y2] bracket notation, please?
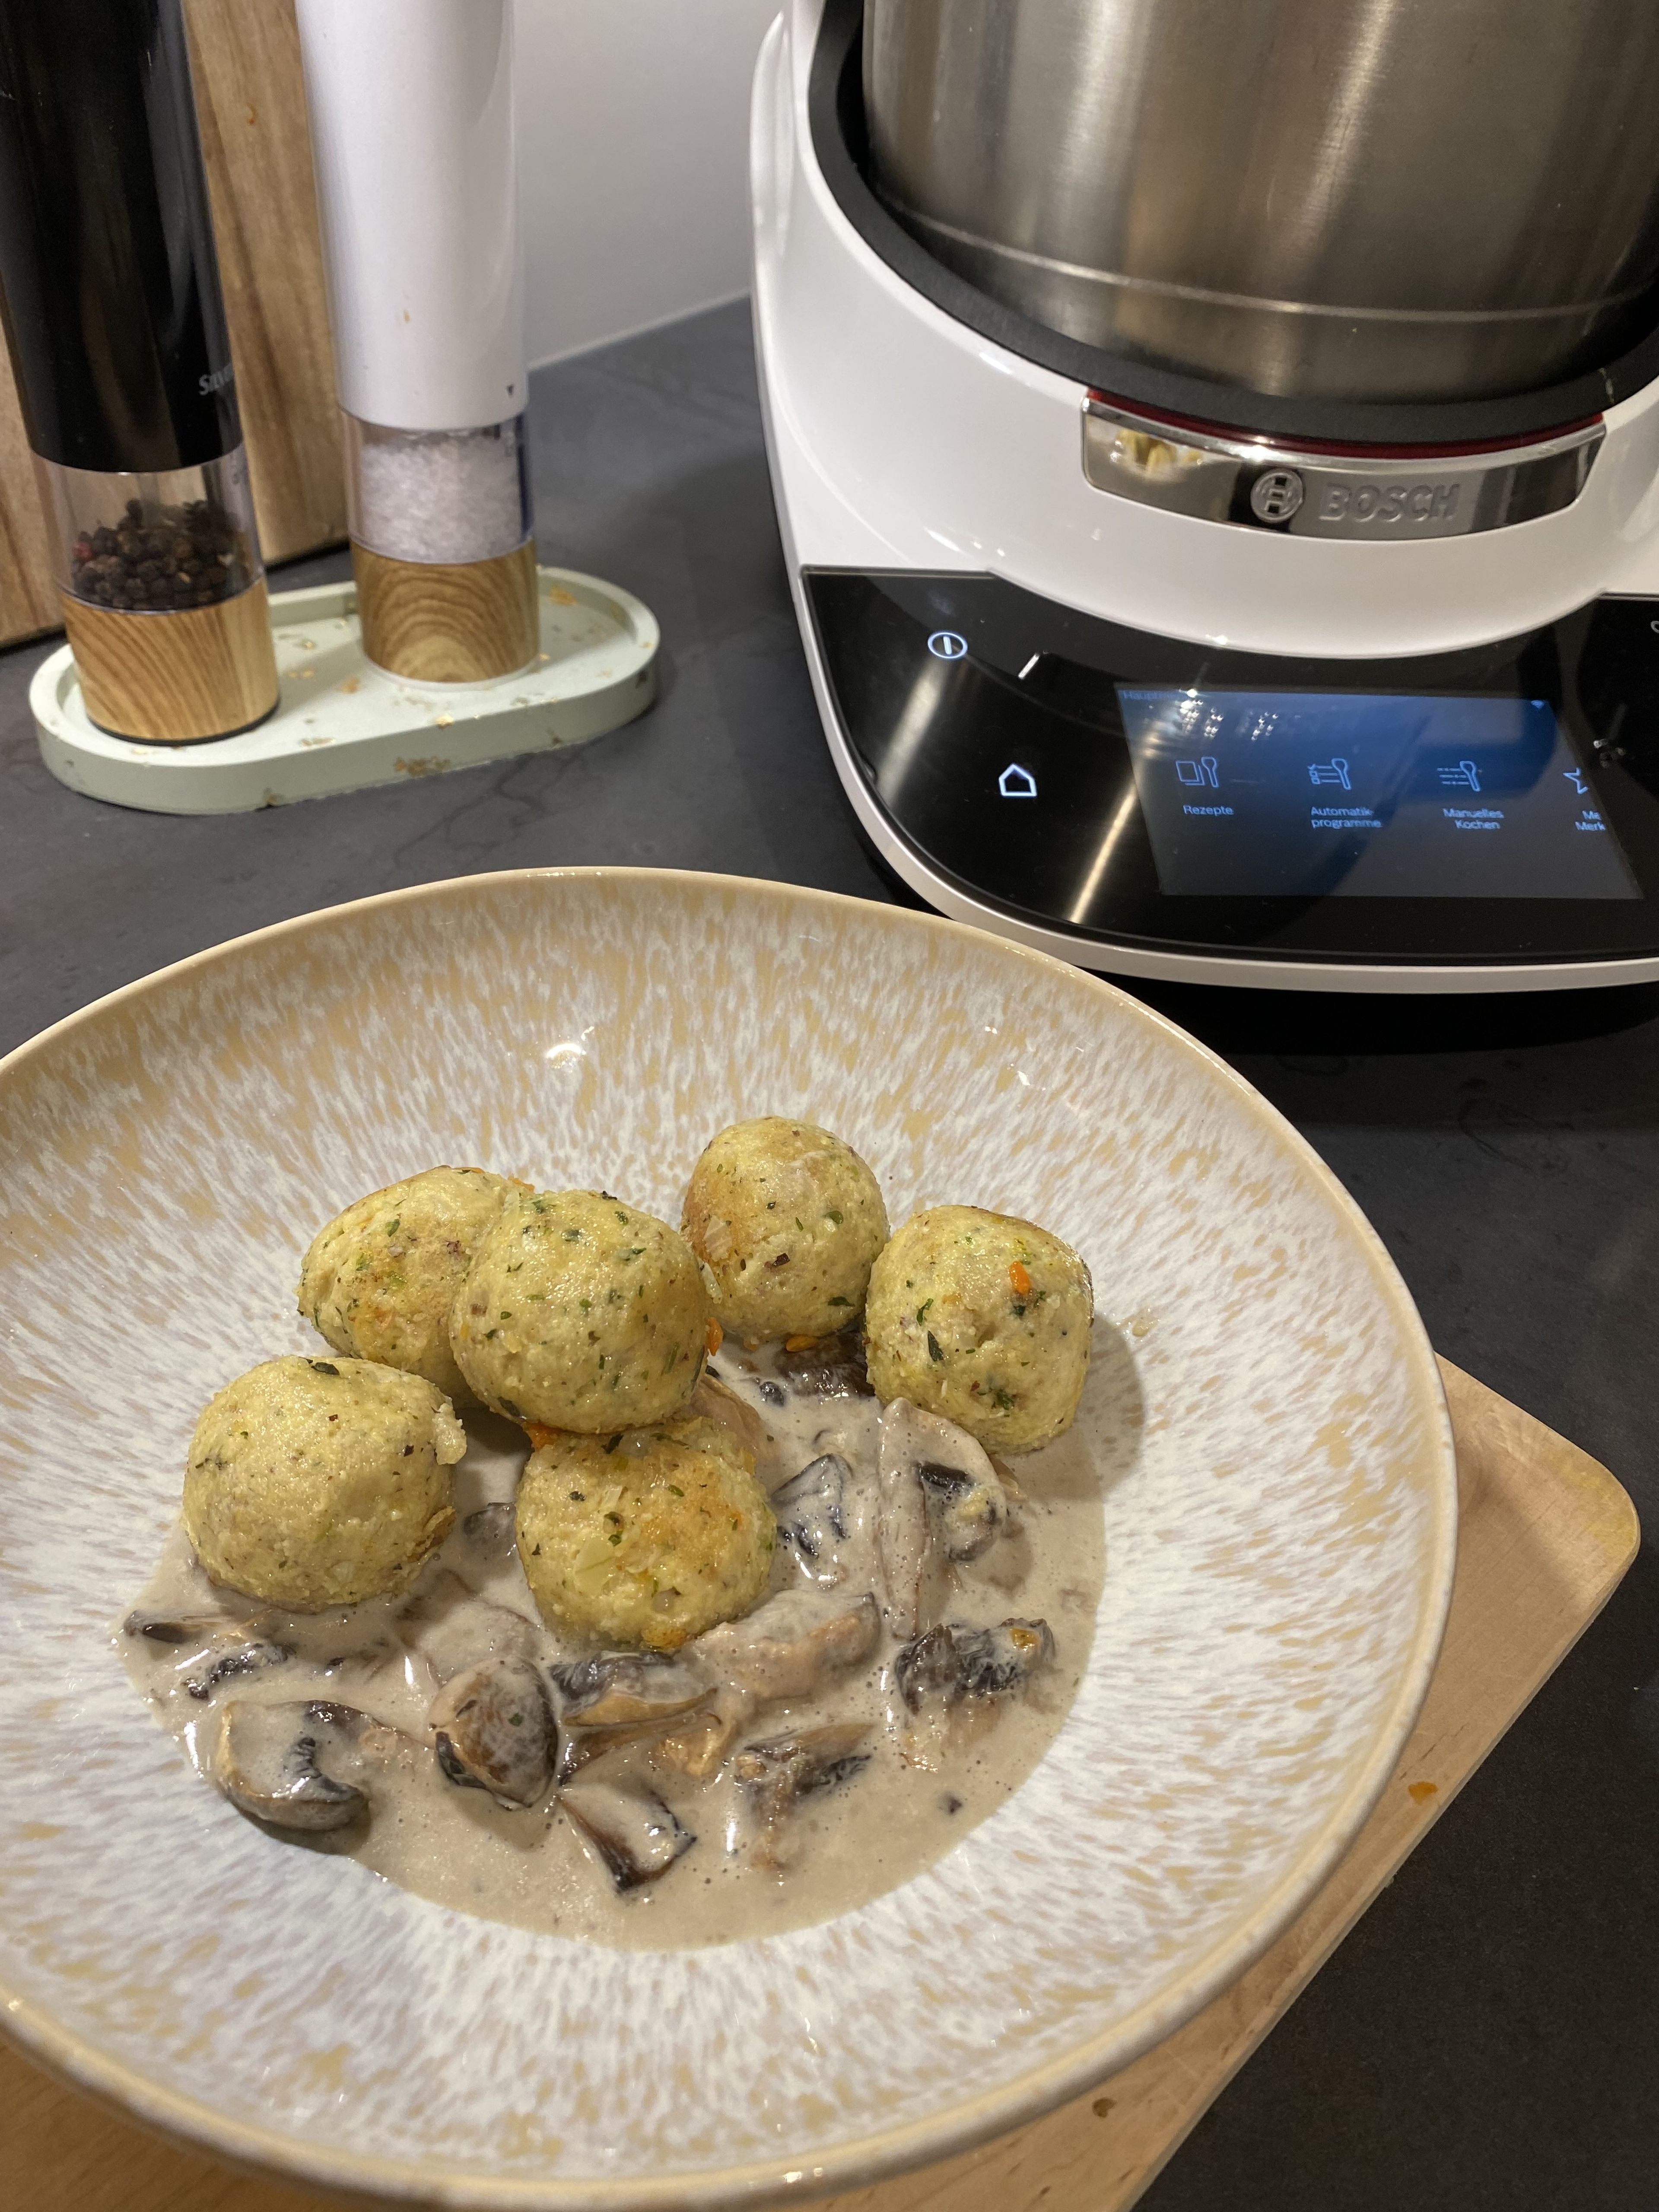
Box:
[449, 1190, 710, 1436]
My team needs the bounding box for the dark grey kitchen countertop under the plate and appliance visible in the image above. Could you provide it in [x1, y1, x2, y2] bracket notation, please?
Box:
[0, 305, 1659, 2212]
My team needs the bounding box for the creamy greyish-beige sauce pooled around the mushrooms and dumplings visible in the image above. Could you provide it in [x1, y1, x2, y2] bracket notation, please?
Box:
[115, 1347, 1106, 1949]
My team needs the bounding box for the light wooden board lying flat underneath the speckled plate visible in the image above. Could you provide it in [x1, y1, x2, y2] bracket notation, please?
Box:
[0, 1360, 1639, 2212]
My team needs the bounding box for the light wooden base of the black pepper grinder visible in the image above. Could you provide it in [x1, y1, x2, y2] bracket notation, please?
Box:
[57, 575, 276, 745]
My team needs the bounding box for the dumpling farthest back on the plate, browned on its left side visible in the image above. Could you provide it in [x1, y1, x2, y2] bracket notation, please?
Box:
[681, 1115, 887, 1345]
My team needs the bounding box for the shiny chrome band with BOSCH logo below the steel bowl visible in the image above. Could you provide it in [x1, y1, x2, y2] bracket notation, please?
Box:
[1084, 398, 1606, 544]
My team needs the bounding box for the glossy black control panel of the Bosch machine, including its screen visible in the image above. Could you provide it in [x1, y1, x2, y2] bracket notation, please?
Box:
[805, 571, 1659, 964]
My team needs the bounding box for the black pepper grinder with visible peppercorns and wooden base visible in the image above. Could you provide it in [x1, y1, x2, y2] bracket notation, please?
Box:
[0, 0, 279, 743]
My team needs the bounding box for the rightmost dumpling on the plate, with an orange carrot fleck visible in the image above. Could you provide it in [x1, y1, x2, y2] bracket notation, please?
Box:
[865, 1205, 1095, 1451]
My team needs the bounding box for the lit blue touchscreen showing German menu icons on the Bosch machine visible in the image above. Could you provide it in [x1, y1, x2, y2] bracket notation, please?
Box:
[1117, 683, 1641, 898]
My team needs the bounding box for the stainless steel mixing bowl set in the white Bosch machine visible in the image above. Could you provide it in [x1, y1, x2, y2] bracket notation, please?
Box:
[865, 0, 1659, 400]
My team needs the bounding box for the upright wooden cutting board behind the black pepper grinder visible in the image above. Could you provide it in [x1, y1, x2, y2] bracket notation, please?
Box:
[0, 0, 345, 646]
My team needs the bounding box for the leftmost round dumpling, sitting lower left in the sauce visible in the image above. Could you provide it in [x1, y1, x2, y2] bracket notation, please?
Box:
[184, 1356, 467, 1612]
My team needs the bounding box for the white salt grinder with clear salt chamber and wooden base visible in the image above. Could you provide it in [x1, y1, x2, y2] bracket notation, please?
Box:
[296, 0, 537, 683]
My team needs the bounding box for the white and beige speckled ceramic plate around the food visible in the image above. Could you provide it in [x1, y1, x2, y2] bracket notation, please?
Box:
[0, 869, 1456, 2208]
